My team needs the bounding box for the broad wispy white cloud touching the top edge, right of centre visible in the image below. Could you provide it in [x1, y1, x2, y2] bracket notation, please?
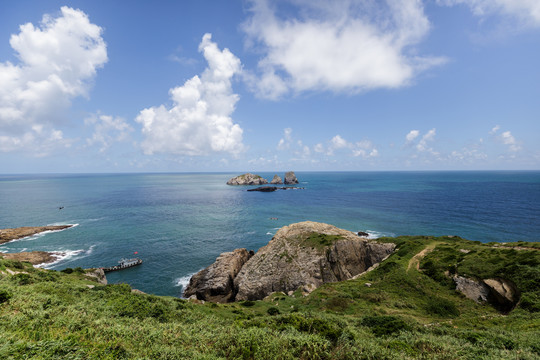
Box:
[243, 0, 445, 99]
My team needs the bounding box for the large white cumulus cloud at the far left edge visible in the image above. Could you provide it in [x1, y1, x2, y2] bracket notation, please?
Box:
[0, 6, 107, 151]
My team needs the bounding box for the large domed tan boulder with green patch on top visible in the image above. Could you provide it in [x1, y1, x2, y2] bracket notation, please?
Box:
[234, 221, 395, 301]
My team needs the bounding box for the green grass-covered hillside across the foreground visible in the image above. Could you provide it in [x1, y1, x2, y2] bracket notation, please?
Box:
[0, 237, 540, 359]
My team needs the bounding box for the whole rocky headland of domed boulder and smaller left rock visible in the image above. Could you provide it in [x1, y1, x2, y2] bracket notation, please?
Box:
[184, 221, 395, 302]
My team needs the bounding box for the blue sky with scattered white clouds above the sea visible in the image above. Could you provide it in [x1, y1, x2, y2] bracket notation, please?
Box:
[0, 0, 540, 173]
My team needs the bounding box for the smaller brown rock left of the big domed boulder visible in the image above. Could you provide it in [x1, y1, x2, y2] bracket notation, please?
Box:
[184, 249, 253, 303]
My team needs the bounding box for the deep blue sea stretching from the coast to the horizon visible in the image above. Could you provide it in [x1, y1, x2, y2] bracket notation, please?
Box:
[0, 172, 540, 296]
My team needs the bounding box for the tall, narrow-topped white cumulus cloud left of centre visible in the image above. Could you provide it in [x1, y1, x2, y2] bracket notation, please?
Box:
[135, 34, 244, 155]
